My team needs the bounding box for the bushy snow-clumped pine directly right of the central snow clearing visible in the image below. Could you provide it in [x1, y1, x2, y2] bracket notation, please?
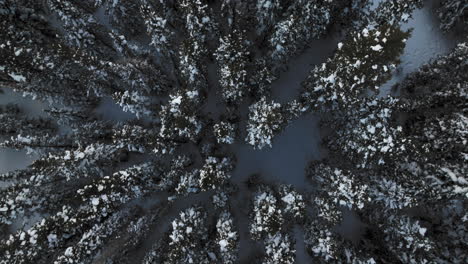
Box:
[322, 97, 411, 168]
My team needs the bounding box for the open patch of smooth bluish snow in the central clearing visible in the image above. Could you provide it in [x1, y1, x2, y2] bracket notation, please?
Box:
[233, 114, 321, 190]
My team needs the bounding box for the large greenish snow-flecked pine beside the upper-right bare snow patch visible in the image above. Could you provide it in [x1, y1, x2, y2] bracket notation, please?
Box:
[302, 24, 410, 110]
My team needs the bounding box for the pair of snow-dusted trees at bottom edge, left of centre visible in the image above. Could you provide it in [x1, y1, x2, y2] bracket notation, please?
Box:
[142, 206, 239, 263]
